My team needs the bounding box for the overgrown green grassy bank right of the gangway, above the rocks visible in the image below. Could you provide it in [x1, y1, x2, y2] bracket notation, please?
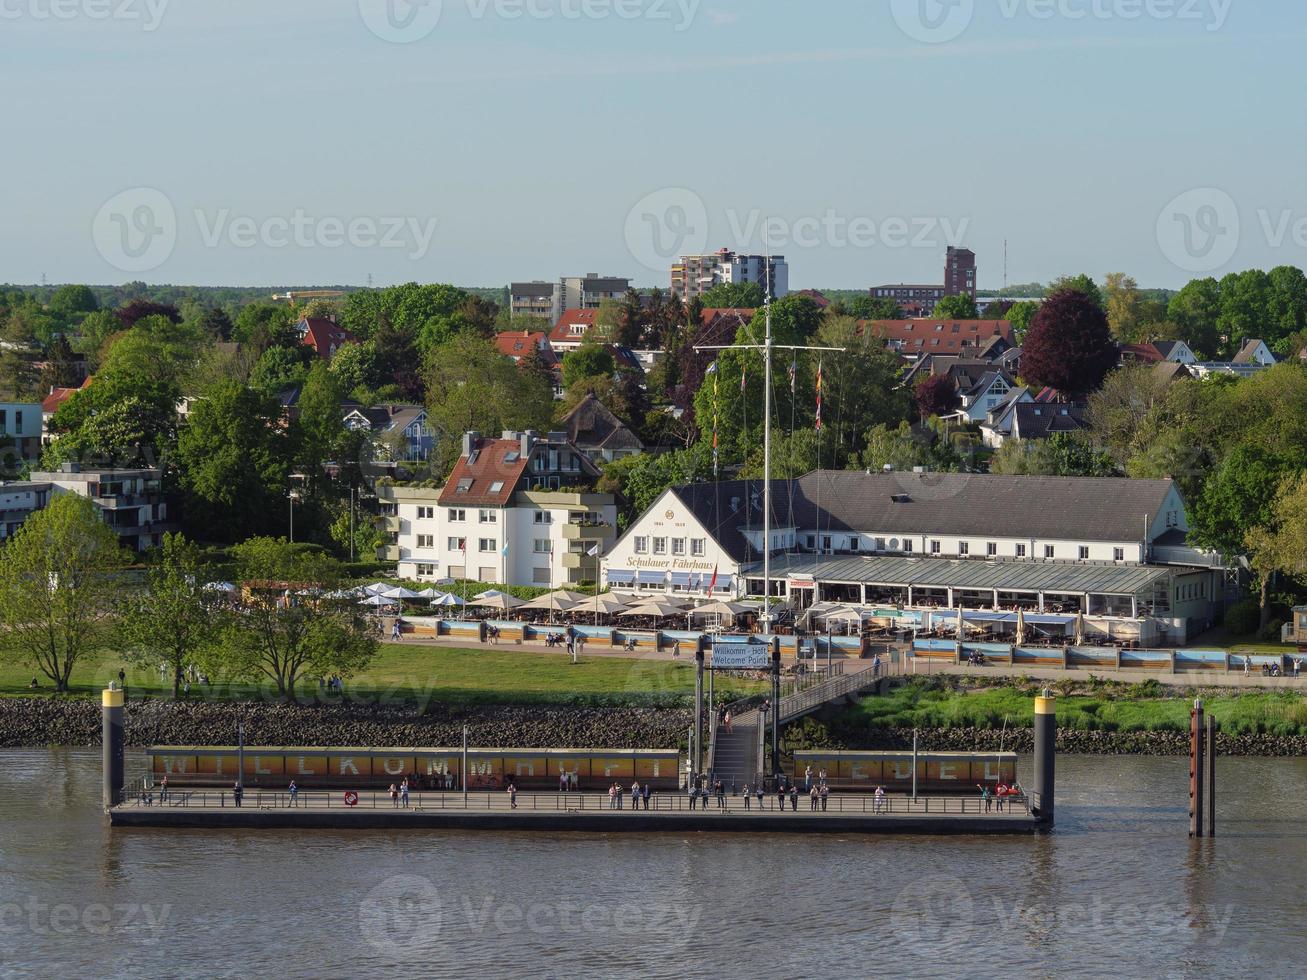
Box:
[833, 682, 1307, 734]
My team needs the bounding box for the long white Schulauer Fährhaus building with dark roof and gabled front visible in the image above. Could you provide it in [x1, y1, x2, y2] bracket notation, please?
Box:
[604, 470, 1227, 643]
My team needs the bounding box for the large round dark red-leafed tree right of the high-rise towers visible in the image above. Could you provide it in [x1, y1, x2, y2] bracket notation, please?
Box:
[1021, 289, 1119, 397]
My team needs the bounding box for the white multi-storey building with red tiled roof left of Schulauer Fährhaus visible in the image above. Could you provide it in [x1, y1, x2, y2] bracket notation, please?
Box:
[378, 433, 617, 588]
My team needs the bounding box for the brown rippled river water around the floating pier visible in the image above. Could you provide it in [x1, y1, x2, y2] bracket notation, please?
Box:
[0, 750, 1307, 977]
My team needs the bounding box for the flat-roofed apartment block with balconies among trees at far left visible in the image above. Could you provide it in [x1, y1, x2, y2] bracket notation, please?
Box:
[31, 463, 180, 553]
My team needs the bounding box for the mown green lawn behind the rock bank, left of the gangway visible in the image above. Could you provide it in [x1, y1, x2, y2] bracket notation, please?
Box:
[0, 644, 763, 704]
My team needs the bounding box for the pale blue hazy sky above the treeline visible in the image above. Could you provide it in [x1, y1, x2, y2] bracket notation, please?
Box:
[0, 0, 1307, 289]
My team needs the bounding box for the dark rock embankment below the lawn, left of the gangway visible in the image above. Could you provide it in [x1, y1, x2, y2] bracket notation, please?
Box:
[0, 698, 694, 749]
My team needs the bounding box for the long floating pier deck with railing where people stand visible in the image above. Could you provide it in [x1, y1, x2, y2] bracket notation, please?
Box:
[108, 789, 1043, 835]
